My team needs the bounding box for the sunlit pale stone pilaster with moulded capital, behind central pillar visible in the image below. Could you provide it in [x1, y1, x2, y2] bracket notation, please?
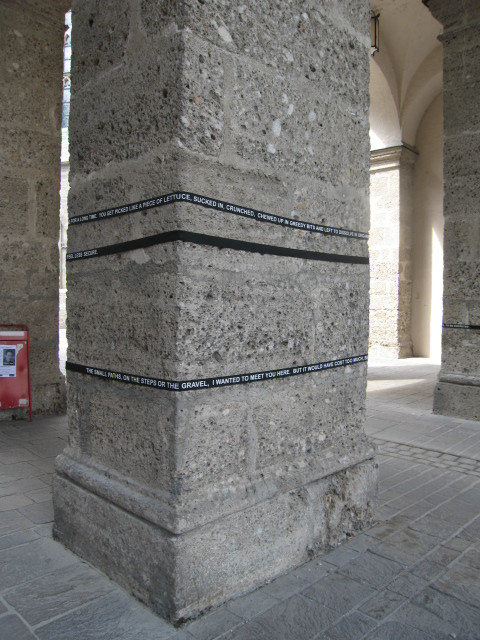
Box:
[369, 145, 416, 358]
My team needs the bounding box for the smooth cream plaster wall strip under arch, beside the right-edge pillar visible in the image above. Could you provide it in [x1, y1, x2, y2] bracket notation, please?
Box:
[412, 94, 443, 361]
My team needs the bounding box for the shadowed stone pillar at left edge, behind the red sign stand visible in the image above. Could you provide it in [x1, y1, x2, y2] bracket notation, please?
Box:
[0, 0, 66, 418]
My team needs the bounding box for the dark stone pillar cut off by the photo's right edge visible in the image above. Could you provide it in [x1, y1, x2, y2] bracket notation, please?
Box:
[427, 0, 480, 420]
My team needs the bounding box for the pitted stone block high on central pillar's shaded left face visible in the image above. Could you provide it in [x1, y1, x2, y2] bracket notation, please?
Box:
[69, 31, 184, 176]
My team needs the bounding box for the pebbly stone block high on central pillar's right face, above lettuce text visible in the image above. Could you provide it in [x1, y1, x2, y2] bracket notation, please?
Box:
[231, 60, 365, 185]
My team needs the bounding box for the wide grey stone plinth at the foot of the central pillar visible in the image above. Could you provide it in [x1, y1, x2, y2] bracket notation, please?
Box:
[53, 455, 377, 622]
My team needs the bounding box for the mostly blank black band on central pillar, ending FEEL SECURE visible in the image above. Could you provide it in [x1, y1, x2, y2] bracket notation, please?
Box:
[67, 230, 368, 264]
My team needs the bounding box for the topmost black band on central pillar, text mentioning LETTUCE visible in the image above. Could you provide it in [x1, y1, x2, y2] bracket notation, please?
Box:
[68, 191, 368, 240]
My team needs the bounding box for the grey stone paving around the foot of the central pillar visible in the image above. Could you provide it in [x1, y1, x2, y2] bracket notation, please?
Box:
[0, 359, 480, 640]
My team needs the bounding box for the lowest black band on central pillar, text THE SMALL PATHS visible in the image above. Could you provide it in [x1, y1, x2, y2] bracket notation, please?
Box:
[66, 354, 368, 391]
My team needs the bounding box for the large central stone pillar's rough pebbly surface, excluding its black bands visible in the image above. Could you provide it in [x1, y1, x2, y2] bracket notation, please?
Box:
[54, 0, 377, 620]
